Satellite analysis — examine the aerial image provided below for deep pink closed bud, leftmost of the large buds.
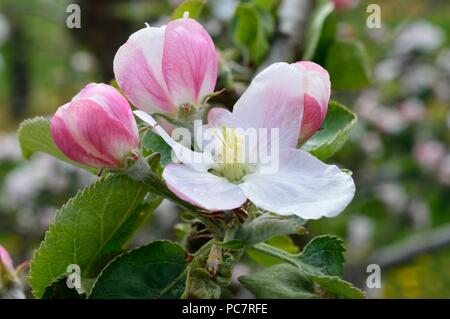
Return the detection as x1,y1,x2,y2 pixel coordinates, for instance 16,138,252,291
51,83,139,168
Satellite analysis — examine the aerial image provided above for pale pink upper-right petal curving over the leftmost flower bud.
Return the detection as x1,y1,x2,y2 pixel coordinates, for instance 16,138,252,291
73,83,139,138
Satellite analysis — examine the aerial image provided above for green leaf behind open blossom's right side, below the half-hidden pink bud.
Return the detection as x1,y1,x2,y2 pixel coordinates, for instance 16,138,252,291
301,101,357,160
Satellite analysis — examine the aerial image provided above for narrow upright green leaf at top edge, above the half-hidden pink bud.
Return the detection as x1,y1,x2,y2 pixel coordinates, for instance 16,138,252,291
303,0,334,60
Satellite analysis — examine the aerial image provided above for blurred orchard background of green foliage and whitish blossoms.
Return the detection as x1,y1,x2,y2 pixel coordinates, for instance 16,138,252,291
0,0,450,298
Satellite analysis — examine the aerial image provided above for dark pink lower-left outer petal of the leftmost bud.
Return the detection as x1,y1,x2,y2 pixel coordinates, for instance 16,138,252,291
50,109,116,168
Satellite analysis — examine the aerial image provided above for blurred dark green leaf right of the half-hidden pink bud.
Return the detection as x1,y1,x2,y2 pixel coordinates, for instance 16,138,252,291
325,40,371,91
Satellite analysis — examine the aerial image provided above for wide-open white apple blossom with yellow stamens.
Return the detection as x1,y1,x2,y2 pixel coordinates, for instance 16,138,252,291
135,63,355,219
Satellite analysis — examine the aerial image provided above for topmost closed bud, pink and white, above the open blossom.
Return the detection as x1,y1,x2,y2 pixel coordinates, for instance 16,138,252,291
114,16,218,115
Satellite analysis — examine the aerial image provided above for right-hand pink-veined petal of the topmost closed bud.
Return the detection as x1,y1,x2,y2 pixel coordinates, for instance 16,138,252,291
163,18,218,106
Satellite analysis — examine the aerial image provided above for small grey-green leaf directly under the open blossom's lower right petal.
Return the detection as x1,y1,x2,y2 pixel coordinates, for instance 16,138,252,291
236,213,306,246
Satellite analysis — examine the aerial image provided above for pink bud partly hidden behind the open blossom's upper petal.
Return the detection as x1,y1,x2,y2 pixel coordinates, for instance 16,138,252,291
294,61,331,143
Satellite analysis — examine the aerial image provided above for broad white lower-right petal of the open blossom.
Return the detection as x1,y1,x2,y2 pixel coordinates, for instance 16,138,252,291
240,149,355,219
